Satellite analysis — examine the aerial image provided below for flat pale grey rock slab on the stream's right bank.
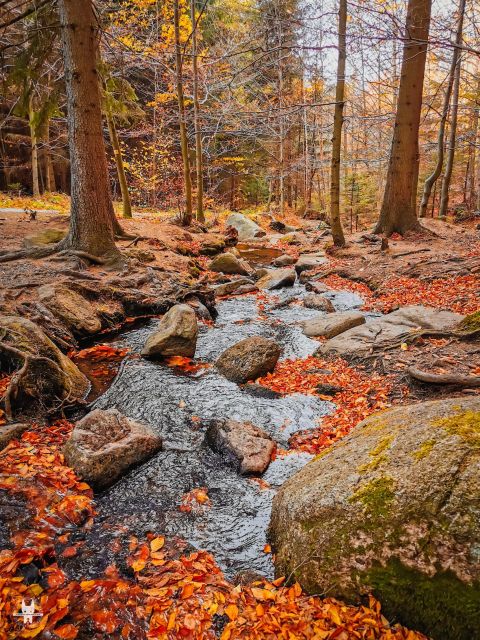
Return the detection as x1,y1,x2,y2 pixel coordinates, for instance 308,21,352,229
319,306,463,356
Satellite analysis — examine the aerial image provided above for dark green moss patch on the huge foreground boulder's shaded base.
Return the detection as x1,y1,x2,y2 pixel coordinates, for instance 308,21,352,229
359,559,480,640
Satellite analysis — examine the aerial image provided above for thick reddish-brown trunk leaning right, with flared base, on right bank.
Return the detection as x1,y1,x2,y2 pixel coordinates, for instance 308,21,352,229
375,0,431,236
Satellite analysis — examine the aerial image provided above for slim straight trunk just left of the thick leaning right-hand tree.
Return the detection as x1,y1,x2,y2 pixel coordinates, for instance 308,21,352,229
330,0,347,247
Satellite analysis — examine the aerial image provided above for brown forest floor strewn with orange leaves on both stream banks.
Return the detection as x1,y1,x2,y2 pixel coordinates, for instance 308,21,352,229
0,202,480,640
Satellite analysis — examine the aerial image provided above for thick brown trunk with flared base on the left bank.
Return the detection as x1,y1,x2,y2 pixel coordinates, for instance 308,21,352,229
58,0,120,261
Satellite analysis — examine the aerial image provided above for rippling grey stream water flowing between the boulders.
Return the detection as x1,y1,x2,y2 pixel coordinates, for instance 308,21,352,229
70,264,362,577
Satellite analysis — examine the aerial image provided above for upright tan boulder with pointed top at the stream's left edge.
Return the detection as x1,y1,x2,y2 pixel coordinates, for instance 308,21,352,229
142,304,198,358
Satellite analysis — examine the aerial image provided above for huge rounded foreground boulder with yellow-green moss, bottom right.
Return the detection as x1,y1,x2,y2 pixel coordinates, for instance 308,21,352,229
270,397,480,640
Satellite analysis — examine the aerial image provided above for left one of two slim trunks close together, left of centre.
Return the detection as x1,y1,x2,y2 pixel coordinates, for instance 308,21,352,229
173,0,192,227
